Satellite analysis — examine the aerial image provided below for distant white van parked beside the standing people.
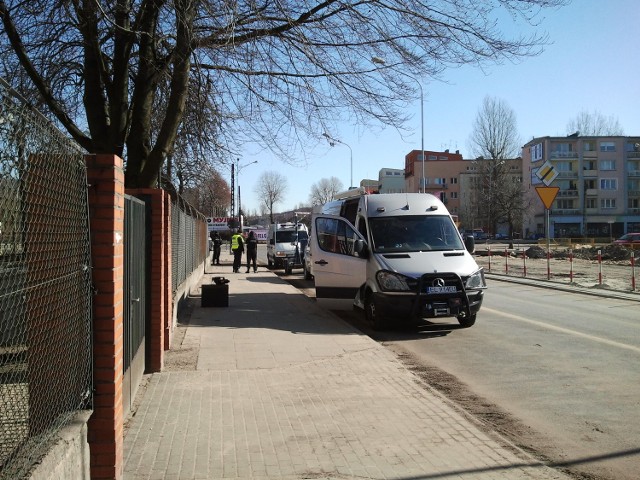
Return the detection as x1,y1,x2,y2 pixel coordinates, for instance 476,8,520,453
267,222,309,273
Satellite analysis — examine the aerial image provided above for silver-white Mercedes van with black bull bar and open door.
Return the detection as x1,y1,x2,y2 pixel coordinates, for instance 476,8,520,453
311,189,486,329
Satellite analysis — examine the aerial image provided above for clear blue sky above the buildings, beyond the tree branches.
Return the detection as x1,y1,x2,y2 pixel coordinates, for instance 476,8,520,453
239,0,640,211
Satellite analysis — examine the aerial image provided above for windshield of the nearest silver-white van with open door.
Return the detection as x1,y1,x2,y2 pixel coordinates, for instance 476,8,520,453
369,215,464,253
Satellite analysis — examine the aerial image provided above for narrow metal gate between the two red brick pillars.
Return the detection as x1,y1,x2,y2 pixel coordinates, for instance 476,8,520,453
122,195,148,409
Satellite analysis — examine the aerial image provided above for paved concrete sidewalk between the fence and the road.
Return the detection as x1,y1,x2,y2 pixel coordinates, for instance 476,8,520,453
124,251,568,480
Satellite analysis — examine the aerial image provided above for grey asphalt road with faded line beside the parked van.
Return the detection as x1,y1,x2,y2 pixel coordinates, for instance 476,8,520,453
258,244,640,480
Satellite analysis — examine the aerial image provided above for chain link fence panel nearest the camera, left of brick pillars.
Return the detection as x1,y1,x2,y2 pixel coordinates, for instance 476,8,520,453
0,79,92,479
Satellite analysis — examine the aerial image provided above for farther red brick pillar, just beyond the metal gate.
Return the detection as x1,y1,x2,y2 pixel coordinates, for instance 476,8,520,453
126,188,171,373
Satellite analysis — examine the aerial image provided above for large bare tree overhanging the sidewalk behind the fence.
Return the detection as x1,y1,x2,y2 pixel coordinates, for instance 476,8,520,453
0,0,568,187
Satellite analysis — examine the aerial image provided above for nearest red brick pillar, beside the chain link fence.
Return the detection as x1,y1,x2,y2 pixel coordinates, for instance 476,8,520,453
86,154,124,480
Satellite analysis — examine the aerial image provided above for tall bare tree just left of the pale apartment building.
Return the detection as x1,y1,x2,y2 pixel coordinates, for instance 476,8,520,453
470,97,524,234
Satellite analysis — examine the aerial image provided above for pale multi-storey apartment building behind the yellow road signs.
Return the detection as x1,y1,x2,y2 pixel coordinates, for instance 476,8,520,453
522,134,640,238
